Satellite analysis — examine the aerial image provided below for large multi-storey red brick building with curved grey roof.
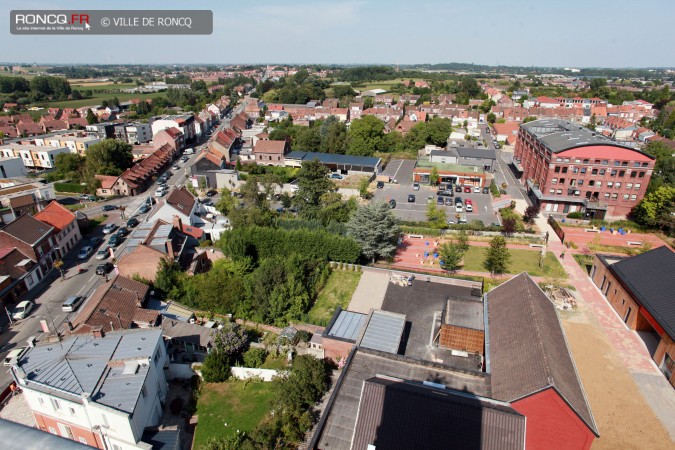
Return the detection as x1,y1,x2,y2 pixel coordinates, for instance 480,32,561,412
514,119,655,219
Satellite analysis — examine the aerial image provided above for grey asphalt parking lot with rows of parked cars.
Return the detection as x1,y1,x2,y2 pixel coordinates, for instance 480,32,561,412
374,182,499,225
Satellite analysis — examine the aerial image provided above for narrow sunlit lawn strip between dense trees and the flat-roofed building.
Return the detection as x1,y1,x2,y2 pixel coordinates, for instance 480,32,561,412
308,269,361,326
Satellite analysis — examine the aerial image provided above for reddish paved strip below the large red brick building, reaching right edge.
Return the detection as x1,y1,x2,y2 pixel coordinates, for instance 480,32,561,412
562,226,668,248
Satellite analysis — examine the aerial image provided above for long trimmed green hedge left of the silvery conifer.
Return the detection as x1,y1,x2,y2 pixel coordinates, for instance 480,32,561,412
218,227,361,263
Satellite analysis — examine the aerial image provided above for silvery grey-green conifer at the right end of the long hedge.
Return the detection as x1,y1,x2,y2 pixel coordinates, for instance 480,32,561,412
347,202,399,263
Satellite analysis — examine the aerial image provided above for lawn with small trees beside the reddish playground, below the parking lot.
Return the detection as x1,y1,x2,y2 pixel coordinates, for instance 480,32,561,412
462,247,567,278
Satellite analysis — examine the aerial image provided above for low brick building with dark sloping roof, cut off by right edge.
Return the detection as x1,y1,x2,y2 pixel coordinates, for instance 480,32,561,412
591,246,675,387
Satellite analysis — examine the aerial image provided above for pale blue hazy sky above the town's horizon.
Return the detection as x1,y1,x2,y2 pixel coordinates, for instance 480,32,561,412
0,0,675,67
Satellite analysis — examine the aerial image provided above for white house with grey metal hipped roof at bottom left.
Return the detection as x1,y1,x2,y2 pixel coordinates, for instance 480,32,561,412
12,324,168,450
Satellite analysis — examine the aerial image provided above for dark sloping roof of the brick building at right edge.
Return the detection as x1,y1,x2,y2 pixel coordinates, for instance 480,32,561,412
609,245,675,339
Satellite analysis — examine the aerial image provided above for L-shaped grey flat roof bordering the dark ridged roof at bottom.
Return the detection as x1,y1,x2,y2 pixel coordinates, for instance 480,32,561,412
312,348,490,450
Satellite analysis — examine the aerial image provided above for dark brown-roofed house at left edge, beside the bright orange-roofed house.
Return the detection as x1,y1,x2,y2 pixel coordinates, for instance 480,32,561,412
0,214,56,280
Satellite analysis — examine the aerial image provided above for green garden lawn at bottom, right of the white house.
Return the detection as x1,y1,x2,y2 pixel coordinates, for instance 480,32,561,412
193,380,272,450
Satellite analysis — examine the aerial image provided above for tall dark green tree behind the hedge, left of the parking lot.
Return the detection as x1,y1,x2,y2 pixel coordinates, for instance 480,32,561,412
293,159,335,219
